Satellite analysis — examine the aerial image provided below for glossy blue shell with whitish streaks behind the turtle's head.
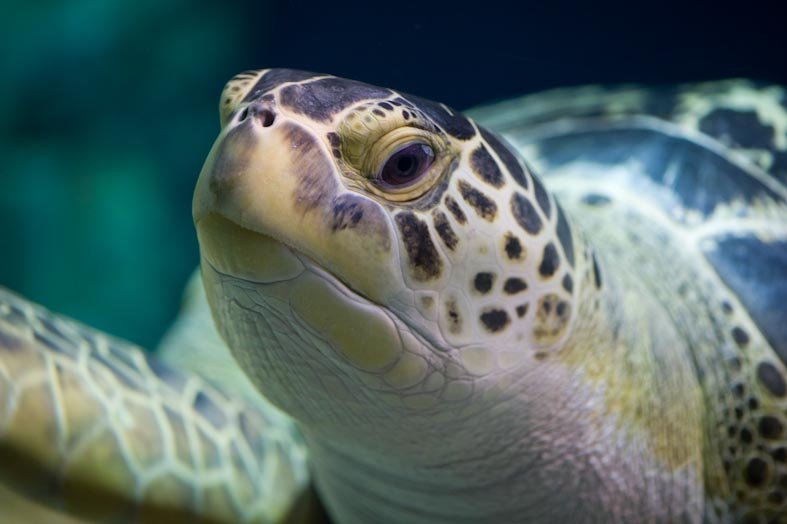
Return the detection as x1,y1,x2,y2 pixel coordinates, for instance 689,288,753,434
471,80,787,365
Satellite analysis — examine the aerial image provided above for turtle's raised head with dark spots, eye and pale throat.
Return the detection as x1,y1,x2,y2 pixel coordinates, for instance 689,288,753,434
193,69,587,446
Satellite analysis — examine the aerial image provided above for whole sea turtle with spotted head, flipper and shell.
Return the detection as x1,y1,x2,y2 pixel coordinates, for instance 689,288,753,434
0,69,787,524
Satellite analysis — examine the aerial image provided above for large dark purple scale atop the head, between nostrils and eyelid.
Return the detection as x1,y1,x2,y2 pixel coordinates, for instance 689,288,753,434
280,77,391,122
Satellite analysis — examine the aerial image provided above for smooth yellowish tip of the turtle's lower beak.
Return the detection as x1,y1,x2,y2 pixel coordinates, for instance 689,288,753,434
196,213,306,284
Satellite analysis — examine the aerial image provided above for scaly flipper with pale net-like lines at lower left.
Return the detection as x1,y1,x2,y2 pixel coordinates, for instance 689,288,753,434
0,289,309,523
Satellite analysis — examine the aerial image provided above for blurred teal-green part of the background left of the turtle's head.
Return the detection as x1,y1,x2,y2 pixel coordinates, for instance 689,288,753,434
0,0,265,347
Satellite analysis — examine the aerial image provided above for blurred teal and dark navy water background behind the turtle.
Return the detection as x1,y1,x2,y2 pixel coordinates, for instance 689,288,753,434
0,0,787,348
